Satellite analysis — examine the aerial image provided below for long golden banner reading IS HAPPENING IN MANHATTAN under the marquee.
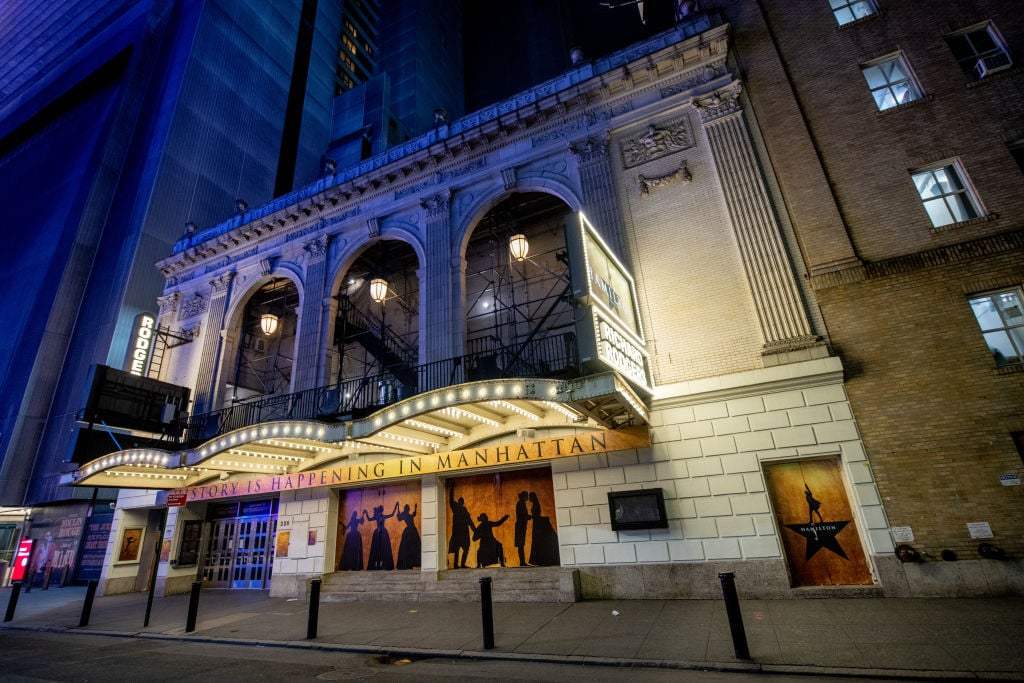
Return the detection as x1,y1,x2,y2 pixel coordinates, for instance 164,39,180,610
179,427,650,503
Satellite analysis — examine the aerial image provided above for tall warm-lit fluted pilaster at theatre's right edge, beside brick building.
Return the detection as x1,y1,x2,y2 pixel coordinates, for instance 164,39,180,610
692,81,818,355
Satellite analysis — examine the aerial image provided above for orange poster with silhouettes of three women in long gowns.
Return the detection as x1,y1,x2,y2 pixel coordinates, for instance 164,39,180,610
335,482,422,571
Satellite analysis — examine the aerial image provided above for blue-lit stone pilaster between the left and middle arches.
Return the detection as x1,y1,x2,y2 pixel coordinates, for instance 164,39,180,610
292,236,330,391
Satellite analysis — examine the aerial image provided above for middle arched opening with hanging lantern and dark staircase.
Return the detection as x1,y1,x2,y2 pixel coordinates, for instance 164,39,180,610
331,240,420,405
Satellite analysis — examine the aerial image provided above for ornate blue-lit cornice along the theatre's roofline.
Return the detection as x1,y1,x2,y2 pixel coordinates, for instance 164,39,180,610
158,10,729,274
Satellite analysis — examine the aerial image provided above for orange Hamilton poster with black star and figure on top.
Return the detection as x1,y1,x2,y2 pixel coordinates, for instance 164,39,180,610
765,458,871,586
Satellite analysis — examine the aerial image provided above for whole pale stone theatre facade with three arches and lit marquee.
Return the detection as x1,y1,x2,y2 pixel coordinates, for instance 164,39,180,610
68,12,899,600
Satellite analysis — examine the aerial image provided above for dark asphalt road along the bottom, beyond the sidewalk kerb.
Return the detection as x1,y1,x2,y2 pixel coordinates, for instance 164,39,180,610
0,631,880,683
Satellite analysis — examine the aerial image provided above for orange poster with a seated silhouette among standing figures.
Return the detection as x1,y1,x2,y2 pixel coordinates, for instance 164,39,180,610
444,467,560,569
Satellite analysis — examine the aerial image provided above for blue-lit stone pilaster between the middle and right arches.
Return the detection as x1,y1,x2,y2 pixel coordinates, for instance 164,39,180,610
420,190,463,364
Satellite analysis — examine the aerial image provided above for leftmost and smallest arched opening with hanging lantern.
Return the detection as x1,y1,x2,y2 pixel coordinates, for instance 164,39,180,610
225,278,299,404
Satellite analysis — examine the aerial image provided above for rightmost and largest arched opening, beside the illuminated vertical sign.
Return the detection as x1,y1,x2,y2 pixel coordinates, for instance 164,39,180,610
465,193,577,379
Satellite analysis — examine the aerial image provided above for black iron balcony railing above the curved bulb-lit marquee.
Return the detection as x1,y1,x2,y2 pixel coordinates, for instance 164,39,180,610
181,332,581,447
